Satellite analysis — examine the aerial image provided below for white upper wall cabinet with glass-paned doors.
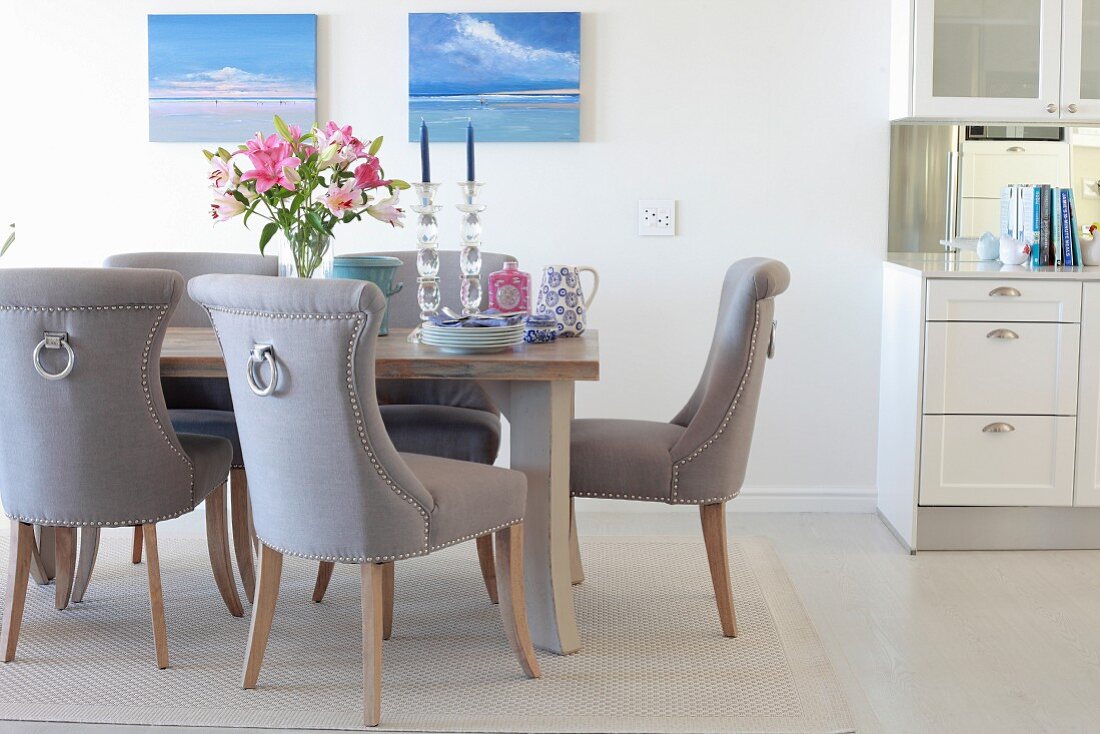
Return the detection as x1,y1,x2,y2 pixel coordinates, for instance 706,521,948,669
890,0,1100,123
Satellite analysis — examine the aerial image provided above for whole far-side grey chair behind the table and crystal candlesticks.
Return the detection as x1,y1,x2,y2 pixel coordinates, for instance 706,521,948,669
314,250,516,604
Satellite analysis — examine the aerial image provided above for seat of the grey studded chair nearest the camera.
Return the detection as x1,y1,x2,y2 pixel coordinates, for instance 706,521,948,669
402,453,527,548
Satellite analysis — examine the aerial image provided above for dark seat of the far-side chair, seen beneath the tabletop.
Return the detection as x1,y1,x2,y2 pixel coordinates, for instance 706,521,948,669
380,405,501,464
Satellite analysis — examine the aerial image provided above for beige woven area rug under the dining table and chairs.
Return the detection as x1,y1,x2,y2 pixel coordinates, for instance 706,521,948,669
0,538,851,734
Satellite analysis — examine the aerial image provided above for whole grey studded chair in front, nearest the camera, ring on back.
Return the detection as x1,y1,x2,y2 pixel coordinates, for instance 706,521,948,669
188,275,539,725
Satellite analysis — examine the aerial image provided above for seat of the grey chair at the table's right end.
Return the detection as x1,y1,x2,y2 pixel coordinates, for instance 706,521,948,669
569,419,684,502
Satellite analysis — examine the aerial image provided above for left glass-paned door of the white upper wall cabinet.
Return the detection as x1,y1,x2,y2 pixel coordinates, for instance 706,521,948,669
913,0,1062,120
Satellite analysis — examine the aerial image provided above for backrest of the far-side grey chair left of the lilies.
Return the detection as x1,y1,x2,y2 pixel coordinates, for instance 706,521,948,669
103,252,278,327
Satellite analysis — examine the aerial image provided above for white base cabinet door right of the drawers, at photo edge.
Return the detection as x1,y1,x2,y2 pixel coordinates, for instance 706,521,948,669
1074,283,1100,507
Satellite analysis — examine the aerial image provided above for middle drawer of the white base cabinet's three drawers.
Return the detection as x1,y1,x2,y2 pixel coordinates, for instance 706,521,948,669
924,321,1081,415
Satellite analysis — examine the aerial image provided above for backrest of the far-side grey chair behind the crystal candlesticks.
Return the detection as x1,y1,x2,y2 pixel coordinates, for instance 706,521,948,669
363,250,516,415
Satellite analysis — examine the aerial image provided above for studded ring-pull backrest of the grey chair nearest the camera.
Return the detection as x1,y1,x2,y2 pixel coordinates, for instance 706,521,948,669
188,275,435,562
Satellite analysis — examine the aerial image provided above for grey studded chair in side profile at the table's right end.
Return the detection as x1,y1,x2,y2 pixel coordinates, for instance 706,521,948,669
570,258,790,637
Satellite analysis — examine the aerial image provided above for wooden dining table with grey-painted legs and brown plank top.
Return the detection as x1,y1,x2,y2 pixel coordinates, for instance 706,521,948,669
161,327,600,655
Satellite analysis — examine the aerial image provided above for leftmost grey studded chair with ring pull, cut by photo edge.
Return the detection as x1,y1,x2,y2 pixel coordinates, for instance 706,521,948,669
0,269,241,668
